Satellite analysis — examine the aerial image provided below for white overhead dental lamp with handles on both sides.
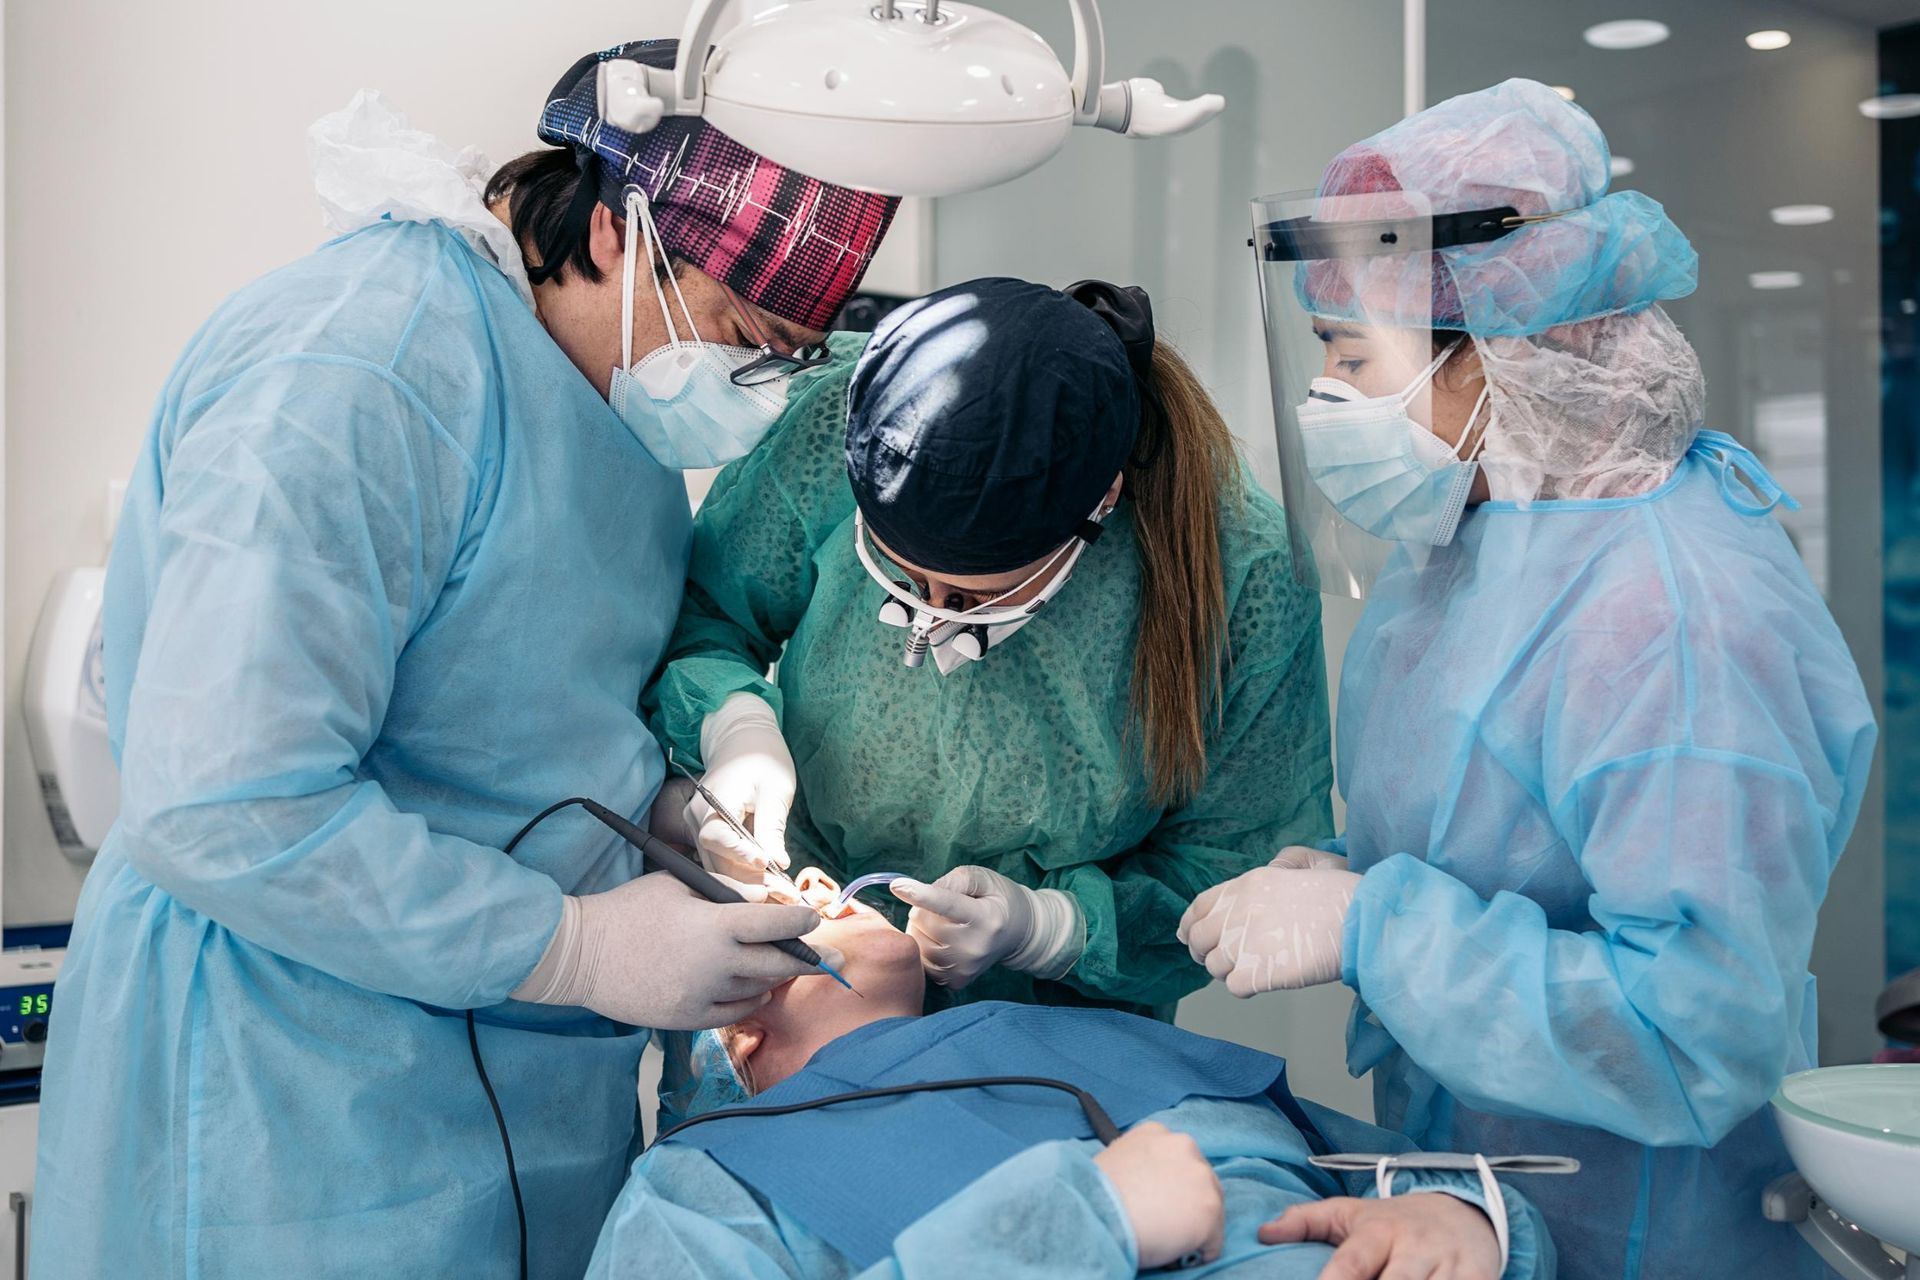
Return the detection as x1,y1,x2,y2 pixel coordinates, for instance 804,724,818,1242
597,0,1225,196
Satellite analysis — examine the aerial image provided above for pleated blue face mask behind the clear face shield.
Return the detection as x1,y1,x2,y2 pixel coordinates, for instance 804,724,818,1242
1296,344,1486,547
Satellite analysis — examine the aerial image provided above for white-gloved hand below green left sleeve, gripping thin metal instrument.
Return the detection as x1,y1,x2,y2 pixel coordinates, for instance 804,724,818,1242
687,693,797,885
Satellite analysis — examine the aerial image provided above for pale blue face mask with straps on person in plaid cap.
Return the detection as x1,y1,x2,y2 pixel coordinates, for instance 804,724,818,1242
607,190,787,470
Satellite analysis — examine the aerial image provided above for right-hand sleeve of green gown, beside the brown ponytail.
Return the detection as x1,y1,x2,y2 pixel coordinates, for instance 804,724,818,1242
1043,558,1332,1006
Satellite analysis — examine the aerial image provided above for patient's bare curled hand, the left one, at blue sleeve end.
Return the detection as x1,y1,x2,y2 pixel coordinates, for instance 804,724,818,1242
1092,1123,1227,1270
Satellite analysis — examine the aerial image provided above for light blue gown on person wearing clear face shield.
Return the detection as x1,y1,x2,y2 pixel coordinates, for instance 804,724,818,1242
1338,438,1874,1280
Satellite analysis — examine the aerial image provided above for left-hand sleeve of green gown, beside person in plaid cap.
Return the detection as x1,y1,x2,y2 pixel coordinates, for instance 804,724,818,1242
641,360,854,760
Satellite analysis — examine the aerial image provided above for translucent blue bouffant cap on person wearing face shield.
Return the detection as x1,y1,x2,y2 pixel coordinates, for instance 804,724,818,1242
1296,79,1699,338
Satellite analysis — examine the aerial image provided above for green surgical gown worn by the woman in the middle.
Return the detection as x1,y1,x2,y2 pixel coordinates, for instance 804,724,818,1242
647,345,1331,1017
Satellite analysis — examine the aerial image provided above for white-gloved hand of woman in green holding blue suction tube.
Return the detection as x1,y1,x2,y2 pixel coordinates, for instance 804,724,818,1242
889,865,1087,990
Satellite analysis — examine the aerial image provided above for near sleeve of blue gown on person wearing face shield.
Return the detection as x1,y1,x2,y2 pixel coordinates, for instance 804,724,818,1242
1344,747,1834,1146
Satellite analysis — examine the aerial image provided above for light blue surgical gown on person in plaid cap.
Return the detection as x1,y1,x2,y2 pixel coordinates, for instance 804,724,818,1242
33,223,689,1280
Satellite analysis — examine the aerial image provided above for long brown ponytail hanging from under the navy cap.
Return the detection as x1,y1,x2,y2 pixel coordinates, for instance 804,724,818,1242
1123,342,1244,808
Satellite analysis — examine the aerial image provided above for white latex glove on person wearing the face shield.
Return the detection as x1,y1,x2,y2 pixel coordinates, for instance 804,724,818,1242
1175,865,1359,998
